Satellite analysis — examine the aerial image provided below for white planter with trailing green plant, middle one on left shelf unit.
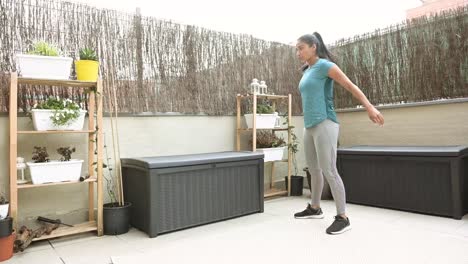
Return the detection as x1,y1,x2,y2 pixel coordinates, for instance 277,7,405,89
31,109,86,131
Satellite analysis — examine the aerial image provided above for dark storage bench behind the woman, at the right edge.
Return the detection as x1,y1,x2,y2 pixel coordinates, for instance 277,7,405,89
337,146,468,219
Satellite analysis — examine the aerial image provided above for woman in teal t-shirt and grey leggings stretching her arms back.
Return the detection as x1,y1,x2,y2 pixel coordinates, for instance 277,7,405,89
294,32,384,234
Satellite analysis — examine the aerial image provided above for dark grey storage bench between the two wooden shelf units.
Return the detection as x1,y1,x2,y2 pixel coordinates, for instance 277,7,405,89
122,152,264,237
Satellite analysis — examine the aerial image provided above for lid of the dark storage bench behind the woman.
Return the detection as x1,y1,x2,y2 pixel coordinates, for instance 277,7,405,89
338,146,468,157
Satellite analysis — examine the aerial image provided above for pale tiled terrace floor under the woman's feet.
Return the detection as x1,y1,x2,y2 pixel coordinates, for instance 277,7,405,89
4,192,468,264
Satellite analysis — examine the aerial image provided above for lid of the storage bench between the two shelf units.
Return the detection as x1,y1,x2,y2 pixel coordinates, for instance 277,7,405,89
121,151,264,169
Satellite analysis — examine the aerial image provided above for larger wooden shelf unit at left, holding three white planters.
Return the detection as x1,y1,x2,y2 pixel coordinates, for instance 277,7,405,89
9,72,103,241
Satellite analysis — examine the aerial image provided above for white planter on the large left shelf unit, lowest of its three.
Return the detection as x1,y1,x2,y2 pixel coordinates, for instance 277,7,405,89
26,159,83,184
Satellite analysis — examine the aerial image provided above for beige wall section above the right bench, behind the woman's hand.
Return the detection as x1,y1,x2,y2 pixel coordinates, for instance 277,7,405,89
338,100,468,146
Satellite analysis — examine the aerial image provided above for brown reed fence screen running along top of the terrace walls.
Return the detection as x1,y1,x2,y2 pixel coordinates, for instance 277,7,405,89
0,0,468,115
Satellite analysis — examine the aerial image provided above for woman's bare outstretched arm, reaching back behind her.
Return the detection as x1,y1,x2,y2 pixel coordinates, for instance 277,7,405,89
328,65,384,126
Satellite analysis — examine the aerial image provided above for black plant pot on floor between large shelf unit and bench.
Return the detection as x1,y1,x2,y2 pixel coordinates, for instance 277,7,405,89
103,202,132,235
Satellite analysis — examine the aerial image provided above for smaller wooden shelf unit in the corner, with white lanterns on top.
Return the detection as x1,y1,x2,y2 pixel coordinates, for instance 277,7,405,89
236,93,292,198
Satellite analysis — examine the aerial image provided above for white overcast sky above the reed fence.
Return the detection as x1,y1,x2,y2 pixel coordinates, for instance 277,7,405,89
68,0,422,44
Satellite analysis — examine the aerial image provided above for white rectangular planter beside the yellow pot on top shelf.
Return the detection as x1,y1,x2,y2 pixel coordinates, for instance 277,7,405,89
16,54,73,80
